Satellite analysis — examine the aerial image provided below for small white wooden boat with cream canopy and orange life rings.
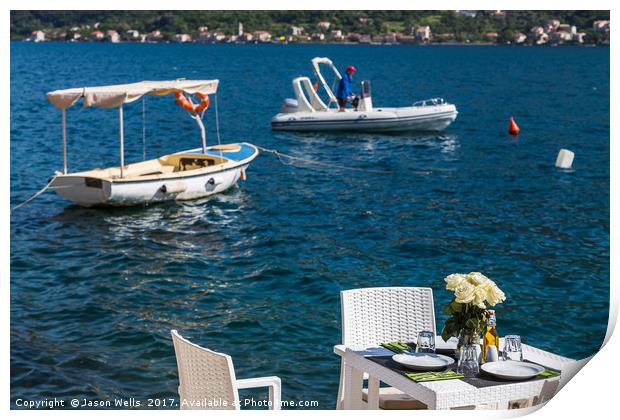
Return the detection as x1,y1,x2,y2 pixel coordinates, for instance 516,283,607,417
47,80,258,207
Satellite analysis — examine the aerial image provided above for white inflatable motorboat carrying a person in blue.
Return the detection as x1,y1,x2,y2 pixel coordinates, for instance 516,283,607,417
271,57,458,132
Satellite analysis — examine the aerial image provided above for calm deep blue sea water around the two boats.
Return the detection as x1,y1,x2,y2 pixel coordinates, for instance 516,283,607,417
10,43,610,408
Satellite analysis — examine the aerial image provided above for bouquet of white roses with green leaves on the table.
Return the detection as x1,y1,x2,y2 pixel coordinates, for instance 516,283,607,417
441,272,506,340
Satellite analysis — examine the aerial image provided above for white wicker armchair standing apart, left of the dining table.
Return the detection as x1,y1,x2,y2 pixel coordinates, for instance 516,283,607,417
171,330,281,410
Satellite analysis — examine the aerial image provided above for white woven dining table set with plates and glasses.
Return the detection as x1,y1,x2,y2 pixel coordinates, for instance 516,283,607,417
334,337,575,410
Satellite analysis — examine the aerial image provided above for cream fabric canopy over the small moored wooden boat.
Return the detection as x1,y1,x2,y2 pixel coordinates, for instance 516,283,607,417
46,79,219,111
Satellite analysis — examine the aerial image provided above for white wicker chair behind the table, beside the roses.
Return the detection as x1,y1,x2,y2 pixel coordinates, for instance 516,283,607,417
334,287,436,409
